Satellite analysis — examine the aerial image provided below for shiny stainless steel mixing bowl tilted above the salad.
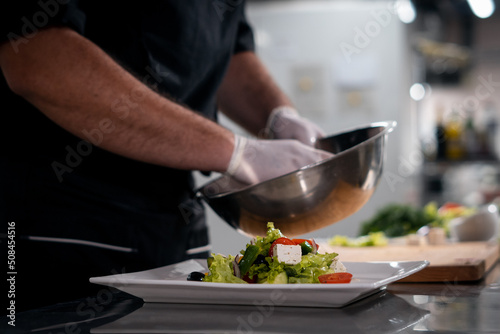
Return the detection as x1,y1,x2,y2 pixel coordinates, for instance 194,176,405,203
197,121,396,237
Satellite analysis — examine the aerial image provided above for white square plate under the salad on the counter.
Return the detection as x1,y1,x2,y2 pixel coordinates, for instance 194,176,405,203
90,260,429,307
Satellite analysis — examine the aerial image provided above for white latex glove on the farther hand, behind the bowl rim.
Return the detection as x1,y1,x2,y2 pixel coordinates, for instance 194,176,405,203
267,106,325,146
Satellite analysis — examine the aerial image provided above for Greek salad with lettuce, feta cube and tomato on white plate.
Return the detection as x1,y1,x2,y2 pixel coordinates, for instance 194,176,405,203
188,223,352,284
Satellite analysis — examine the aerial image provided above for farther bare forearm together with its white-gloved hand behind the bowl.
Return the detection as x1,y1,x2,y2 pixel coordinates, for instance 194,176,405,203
217,52,324,146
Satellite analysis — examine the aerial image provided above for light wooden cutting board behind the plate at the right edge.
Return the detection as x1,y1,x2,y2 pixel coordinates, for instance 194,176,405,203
319,242,499,282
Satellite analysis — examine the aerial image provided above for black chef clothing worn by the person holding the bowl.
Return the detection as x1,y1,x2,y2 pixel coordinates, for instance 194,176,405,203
0,0,253,310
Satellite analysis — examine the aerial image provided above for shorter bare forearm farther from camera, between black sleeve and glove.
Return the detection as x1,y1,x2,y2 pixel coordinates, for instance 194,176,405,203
217,52,292,135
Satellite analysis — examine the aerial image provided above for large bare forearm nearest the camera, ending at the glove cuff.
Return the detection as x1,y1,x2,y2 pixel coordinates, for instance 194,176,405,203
0,28,234,171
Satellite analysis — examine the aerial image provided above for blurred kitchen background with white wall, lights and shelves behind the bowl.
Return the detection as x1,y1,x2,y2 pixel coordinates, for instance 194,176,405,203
197,0,500,254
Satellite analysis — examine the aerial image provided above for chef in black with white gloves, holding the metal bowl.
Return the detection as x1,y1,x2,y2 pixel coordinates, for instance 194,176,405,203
0,0,328,310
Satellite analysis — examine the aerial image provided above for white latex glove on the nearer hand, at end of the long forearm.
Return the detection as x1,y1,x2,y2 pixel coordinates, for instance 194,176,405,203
227,135,333,184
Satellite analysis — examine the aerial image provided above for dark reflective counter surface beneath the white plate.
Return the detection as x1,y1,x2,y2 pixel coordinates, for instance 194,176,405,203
0,263,500,334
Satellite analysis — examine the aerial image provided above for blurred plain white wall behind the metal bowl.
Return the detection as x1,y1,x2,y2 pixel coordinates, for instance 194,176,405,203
198,0,419,253
